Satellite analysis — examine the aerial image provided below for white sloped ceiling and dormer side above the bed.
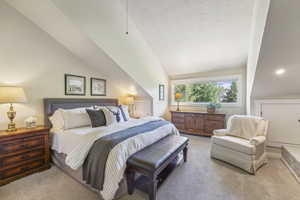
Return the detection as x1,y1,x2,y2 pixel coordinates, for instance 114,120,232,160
6,0,168,116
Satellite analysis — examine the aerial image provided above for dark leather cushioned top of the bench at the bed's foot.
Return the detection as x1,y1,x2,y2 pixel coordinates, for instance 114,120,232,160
127,135,188,171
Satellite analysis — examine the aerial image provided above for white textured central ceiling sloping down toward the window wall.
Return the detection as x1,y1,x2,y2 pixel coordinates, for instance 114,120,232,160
120,0,254,75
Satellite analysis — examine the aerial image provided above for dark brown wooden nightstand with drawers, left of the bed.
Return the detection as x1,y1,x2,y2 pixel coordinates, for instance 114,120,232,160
0,126,50,186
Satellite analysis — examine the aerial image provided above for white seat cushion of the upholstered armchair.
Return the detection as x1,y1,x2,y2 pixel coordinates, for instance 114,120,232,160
211,136,256,155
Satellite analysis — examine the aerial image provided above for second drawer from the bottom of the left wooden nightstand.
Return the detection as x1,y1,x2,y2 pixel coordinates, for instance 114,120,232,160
0,149,45,168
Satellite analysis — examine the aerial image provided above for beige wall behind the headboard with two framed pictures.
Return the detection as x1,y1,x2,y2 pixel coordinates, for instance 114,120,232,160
0,2,151,129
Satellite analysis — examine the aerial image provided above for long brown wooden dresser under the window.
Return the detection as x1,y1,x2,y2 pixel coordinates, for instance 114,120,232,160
171,111,226,136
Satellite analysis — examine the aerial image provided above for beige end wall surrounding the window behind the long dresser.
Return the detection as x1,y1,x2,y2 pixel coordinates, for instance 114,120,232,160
166,67,246,119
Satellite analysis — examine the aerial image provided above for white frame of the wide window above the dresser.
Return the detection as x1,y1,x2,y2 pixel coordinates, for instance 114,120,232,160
171,75,243,107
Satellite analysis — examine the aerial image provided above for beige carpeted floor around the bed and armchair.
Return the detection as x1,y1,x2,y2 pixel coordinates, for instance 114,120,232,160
0,136,300,200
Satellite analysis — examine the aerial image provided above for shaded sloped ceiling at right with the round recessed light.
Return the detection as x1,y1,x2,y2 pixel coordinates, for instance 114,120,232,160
252,0,300,98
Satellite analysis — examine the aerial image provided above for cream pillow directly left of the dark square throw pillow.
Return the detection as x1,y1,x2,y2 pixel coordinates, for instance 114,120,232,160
61,108,91,130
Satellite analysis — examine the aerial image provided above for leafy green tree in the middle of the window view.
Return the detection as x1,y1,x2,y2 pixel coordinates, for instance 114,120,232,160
188,82,220,102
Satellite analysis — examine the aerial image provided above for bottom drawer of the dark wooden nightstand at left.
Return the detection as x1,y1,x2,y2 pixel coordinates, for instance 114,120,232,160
0,160,45,179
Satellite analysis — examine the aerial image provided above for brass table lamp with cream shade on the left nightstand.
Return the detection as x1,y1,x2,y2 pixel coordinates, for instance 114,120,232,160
0,86,27,132
